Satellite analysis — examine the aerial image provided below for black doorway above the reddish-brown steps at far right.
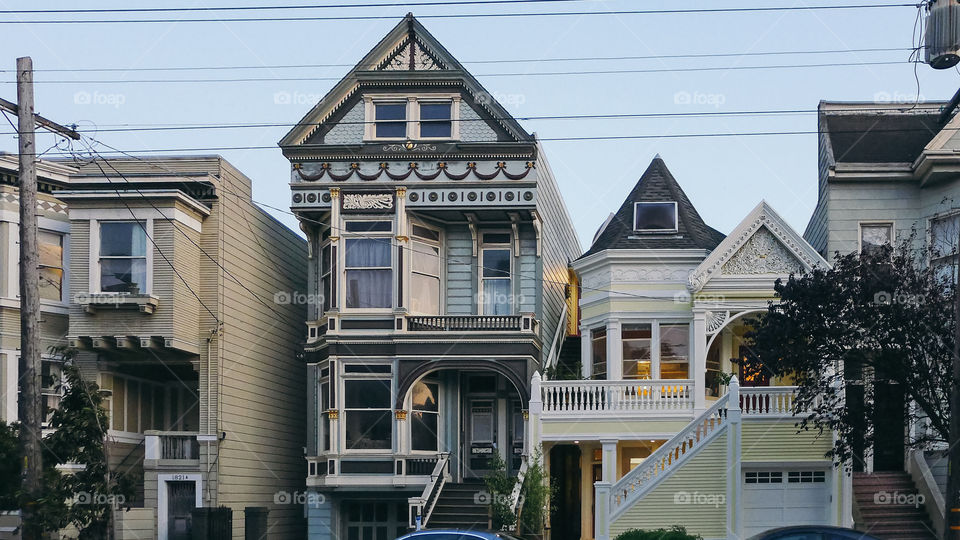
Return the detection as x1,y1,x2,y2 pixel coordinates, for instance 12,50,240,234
873,382,906,472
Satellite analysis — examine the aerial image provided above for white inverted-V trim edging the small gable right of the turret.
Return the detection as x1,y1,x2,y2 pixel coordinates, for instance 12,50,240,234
687,201,829,293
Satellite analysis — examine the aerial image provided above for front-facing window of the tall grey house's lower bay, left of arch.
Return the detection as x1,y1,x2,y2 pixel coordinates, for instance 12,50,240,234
343,378,393,450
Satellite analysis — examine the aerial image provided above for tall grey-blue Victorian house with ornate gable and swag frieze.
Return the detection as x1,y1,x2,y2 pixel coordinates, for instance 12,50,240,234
280,15,580,539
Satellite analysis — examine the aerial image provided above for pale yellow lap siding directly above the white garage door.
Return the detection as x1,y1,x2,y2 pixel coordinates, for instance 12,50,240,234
741,418,833,461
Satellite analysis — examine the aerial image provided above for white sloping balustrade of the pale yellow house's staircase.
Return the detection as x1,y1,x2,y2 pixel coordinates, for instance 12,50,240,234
597,392,738,520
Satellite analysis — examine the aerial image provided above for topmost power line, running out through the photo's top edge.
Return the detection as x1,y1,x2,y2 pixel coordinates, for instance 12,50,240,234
0,0,585,15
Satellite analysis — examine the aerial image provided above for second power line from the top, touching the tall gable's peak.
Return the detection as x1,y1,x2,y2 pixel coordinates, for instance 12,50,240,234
0,3,923,25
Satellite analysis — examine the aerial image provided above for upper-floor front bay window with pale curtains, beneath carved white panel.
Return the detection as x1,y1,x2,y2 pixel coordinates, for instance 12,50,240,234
343,221,393,309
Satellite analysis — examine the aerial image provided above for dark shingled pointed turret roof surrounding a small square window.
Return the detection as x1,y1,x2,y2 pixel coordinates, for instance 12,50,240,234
581,155,724,258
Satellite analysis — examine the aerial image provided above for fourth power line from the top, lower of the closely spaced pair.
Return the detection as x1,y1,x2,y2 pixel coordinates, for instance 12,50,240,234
2,60,917,84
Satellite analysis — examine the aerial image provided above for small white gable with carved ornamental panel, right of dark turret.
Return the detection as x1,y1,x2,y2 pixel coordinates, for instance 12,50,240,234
687,201,830,292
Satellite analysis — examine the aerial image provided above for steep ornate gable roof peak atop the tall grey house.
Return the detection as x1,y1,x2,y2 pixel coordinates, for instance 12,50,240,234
279,13,533,147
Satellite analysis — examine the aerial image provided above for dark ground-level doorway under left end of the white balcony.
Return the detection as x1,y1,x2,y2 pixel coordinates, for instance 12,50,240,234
550,444,580,540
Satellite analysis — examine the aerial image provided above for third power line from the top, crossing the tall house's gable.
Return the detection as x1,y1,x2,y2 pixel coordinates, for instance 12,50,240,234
0,47,916,73
